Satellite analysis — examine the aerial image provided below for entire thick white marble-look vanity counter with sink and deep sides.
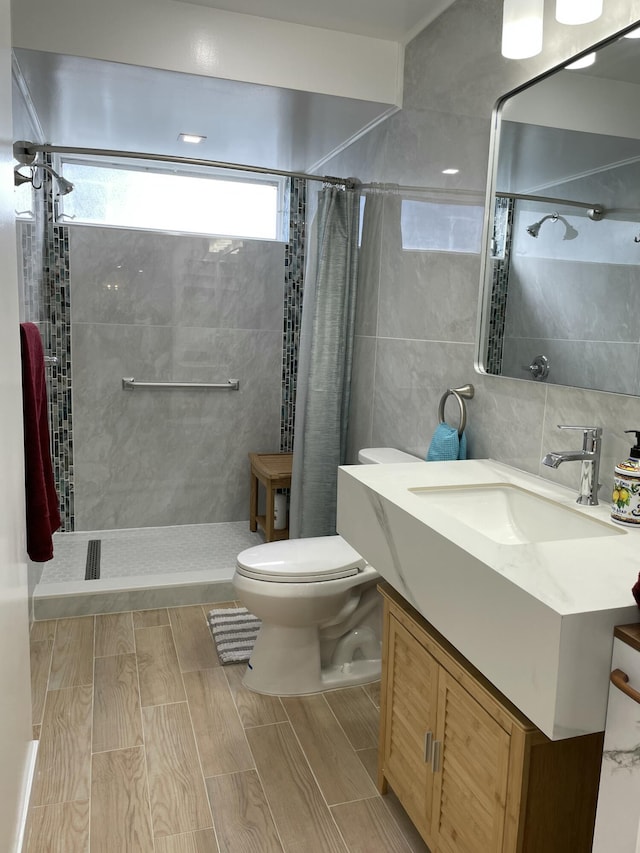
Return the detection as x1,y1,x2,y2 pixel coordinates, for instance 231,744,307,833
338,459,640,739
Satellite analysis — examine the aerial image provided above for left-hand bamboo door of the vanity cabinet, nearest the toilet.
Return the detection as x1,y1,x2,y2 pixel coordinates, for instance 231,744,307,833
383,616,439,839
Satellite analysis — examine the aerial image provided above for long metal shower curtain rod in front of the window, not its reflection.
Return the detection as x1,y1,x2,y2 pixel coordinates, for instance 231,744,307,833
13,141,359,189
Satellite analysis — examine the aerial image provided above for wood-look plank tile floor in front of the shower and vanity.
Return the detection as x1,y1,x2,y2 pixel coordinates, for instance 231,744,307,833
24,604,428,853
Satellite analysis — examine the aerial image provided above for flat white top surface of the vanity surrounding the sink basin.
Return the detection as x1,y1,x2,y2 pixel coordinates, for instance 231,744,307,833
338,459,640,619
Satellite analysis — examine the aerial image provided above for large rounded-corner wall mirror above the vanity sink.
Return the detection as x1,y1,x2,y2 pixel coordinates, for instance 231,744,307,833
477,25,640,395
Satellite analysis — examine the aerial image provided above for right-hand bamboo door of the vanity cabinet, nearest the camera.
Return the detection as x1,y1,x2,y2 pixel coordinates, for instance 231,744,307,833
432,670,510,853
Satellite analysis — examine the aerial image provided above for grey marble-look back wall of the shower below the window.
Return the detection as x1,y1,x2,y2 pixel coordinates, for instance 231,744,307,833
69,227,284,530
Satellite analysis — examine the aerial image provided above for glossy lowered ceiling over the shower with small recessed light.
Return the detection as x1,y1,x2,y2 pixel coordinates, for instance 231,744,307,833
14,49,391,171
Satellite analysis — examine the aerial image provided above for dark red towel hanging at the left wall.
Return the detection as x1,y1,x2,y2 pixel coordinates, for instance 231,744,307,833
20,323,61,563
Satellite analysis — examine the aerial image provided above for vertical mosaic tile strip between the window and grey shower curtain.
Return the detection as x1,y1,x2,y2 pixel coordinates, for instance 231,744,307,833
280,178,307,453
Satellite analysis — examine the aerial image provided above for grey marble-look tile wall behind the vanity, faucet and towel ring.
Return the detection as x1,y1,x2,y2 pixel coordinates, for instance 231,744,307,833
326,0,640,500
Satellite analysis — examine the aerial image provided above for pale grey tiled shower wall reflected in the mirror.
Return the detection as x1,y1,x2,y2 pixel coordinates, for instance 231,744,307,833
502,156,640,394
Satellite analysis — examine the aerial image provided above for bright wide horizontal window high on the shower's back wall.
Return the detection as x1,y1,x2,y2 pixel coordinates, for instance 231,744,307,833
58,160,288,240
